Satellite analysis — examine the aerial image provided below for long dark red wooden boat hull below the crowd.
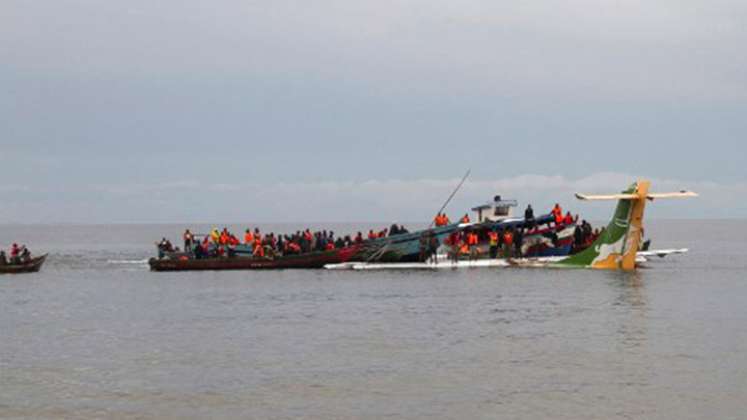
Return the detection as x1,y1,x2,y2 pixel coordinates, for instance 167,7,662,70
148,245,359,271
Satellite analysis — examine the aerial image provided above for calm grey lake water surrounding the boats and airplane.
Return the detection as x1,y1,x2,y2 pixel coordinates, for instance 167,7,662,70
0,220,747,420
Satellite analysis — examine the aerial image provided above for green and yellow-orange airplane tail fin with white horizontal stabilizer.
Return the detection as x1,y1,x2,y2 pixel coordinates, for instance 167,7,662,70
558,180,698,271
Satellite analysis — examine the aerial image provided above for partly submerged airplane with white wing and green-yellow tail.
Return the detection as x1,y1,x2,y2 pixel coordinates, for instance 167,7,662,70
326,180,698,271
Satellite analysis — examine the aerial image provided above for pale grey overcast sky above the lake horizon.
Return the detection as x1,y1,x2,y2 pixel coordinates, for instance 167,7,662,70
0,0,747,223
